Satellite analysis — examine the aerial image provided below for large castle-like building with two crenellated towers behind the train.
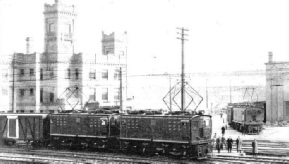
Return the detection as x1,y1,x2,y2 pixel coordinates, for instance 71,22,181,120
10,0,127,113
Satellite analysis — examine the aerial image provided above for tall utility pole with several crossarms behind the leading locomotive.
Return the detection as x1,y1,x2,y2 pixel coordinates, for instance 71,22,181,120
177,27,189,111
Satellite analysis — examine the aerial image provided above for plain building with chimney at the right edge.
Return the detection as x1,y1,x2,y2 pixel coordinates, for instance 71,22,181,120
265,52,289,124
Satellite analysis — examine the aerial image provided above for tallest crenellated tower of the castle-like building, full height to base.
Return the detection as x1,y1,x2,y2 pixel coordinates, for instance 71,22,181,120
39,0,82,112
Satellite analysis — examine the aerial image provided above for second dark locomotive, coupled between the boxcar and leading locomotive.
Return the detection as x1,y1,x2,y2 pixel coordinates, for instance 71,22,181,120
50,113,119,149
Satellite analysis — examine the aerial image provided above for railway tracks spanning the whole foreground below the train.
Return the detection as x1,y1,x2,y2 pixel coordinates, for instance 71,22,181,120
0,140,289,163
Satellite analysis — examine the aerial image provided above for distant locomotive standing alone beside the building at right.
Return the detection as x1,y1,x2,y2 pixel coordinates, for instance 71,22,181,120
227,102,265,134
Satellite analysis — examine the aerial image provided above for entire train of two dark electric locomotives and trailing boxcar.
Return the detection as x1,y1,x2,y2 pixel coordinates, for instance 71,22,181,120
0,112,212,158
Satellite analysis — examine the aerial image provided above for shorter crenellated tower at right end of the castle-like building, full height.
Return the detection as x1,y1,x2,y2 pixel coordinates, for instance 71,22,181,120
101,32,127,110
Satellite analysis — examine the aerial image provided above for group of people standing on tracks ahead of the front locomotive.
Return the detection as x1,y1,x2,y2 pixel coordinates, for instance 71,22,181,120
213,127,258,156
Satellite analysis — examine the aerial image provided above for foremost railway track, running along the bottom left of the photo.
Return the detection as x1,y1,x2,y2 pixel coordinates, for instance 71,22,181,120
0,148,192,163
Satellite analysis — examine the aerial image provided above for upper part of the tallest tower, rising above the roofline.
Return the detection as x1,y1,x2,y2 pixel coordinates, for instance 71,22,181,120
43,0,77,58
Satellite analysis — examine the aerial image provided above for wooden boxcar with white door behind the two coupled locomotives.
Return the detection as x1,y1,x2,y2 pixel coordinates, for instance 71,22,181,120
0,113,49,146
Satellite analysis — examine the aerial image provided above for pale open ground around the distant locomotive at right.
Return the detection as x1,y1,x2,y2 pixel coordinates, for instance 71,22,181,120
212,115,289,142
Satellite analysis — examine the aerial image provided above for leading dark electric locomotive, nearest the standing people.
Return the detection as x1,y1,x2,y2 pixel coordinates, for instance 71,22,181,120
120,115,212,158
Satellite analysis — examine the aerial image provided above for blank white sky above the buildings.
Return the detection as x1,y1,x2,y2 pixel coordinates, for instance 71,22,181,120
0,0,289,110
